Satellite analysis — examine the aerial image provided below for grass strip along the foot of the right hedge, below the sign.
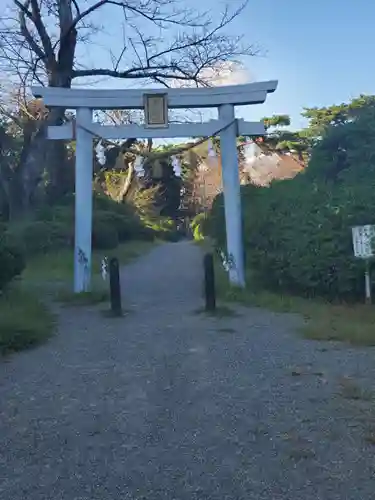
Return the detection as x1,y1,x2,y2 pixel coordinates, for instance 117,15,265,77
215,258,375,346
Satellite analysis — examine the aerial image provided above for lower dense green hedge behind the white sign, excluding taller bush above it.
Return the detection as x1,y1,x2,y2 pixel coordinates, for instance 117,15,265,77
208,174,375,300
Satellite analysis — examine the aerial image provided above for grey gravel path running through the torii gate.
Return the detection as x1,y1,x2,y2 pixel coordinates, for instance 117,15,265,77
0,242,375,500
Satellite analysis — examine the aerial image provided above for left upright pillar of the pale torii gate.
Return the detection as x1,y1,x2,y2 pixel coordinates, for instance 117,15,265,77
74,108,93,293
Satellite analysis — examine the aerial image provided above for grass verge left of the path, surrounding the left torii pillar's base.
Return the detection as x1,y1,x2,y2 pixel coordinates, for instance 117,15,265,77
0,241,155,355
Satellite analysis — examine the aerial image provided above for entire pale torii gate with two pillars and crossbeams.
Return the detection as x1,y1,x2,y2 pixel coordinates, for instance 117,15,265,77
32,81,278,293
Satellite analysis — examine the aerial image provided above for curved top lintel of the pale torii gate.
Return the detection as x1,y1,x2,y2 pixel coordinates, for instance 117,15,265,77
32,80,278,109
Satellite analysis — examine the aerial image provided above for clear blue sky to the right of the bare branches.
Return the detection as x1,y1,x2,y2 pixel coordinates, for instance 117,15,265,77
75,0,375,128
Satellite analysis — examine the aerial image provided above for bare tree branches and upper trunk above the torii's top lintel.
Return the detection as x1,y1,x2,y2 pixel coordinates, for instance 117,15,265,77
0,0,259,87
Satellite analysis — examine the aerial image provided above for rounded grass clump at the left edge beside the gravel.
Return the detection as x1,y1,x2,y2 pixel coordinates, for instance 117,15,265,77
0,284,55,355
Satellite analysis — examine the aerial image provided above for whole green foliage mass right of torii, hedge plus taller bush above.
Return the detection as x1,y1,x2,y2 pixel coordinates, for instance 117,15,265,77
207,97,375,300
